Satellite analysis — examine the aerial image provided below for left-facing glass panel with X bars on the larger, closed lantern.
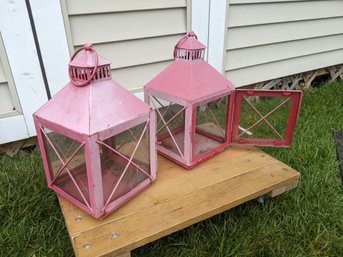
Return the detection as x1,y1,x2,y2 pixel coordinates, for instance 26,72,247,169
43,128,89,204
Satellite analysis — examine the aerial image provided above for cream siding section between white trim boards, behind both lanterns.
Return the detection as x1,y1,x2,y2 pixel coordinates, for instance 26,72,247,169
61,0,189,91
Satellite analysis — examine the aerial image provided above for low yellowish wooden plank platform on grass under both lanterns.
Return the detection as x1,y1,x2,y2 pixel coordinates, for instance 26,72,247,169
59,146,299,257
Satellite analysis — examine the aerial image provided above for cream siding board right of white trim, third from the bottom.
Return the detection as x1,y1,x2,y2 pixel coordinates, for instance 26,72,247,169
227,18,343,49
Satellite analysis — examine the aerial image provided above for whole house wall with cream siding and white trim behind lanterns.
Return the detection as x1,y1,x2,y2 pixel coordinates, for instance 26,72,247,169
0,0,343,144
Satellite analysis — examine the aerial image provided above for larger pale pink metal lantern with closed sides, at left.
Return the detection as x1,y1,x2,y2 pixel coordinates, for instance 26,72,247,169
34,44,156,218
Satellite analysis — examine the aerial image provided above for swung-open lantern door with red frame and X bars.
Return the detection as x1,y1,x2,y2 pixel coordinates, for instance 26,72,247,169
232,89,302,147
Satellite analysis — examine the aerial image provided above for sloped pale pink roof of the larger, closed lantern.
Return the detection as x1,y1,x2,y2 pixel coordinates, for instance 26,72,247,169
35,44,150,135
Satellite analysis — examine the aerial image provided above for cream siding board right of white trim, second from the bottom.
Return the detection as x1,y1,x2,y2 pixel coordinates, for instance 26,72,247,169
225,34,343,70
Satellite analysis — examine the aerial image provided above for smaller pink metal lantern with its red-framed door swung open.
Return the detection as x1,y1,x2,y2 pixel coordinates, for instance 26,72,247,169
144,32,302,168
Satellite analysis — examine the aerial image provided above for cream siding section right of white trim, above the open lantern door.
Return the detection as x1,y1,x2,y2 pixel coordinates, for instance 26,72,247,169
224,0,343,86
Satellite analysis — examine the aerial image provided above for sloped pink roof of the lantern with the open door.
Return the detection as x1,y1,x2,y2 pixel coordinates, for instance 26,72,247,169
144,34,235,102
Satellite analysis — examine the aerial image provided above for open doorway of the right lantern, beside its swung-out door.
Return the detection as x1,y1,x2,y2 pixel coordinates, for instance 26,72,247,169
194,96,229,156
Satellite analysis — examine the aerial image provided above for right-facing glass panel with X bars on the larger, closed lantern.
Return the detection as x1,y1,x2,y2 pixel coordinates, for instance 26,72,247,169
100,122,150,202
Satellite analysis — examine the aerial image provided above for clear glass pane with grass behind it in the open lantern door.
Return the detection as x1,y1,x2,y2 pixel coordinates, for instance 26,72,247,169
238,96,292,139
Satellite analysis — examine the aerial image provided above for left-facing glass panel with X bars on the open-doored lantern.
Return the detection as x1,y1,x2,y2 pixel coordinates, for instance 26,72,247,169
152,97,185,157
